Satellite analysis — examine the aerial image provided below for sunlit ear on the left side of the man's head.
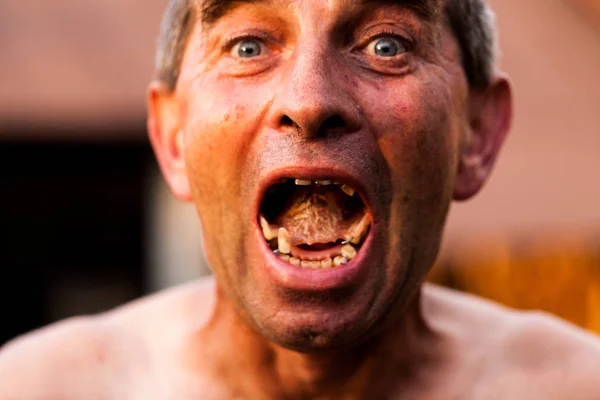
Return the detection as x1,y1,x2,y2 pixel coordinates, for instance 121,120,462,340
148,82,192,201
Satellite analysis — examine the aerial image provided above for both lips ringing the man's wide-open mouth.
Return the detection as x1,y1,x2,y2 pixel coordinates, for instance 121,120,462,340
252,168,376,292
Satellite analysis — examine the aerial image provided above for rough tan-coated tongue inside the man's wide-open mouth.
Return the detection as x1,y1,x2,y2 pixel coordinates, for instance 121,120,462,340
275,187,350,246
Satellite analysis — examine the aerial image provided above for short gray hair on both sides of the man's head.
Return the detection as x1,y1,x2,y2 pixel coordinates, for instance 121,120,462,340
155,0,497,91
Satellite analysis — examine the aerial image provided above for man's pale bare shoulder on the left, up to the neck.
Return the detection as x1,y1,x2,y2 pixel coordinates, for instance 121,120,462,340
0,281,212,400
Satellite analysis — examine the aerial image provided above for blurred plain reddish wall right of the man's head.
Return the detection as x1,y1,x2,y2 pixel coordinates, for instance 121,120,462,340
447,0,600,239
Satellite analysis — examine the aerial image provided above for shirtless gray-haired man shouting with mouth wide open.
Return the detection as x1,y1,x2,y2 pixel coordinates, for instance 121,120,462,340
0,0,600,400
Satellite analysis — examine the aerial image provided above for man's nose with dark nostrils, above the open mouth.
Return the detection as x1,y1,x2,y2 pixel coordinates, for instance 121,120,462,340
269,51,361,139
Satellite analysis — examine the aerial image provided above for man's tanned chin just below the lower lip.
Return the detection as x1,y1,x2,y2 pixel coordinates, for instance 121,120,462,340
243,238,408,353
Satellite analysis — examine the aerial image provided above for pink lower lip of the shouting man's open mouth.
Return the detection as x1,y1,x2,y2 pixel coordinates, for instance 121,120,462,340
255,222,373,292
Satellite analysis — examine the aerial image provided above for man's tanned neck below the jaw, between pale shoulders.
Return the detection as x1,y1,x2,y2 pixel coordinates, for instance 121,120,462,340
195,282,436,398
